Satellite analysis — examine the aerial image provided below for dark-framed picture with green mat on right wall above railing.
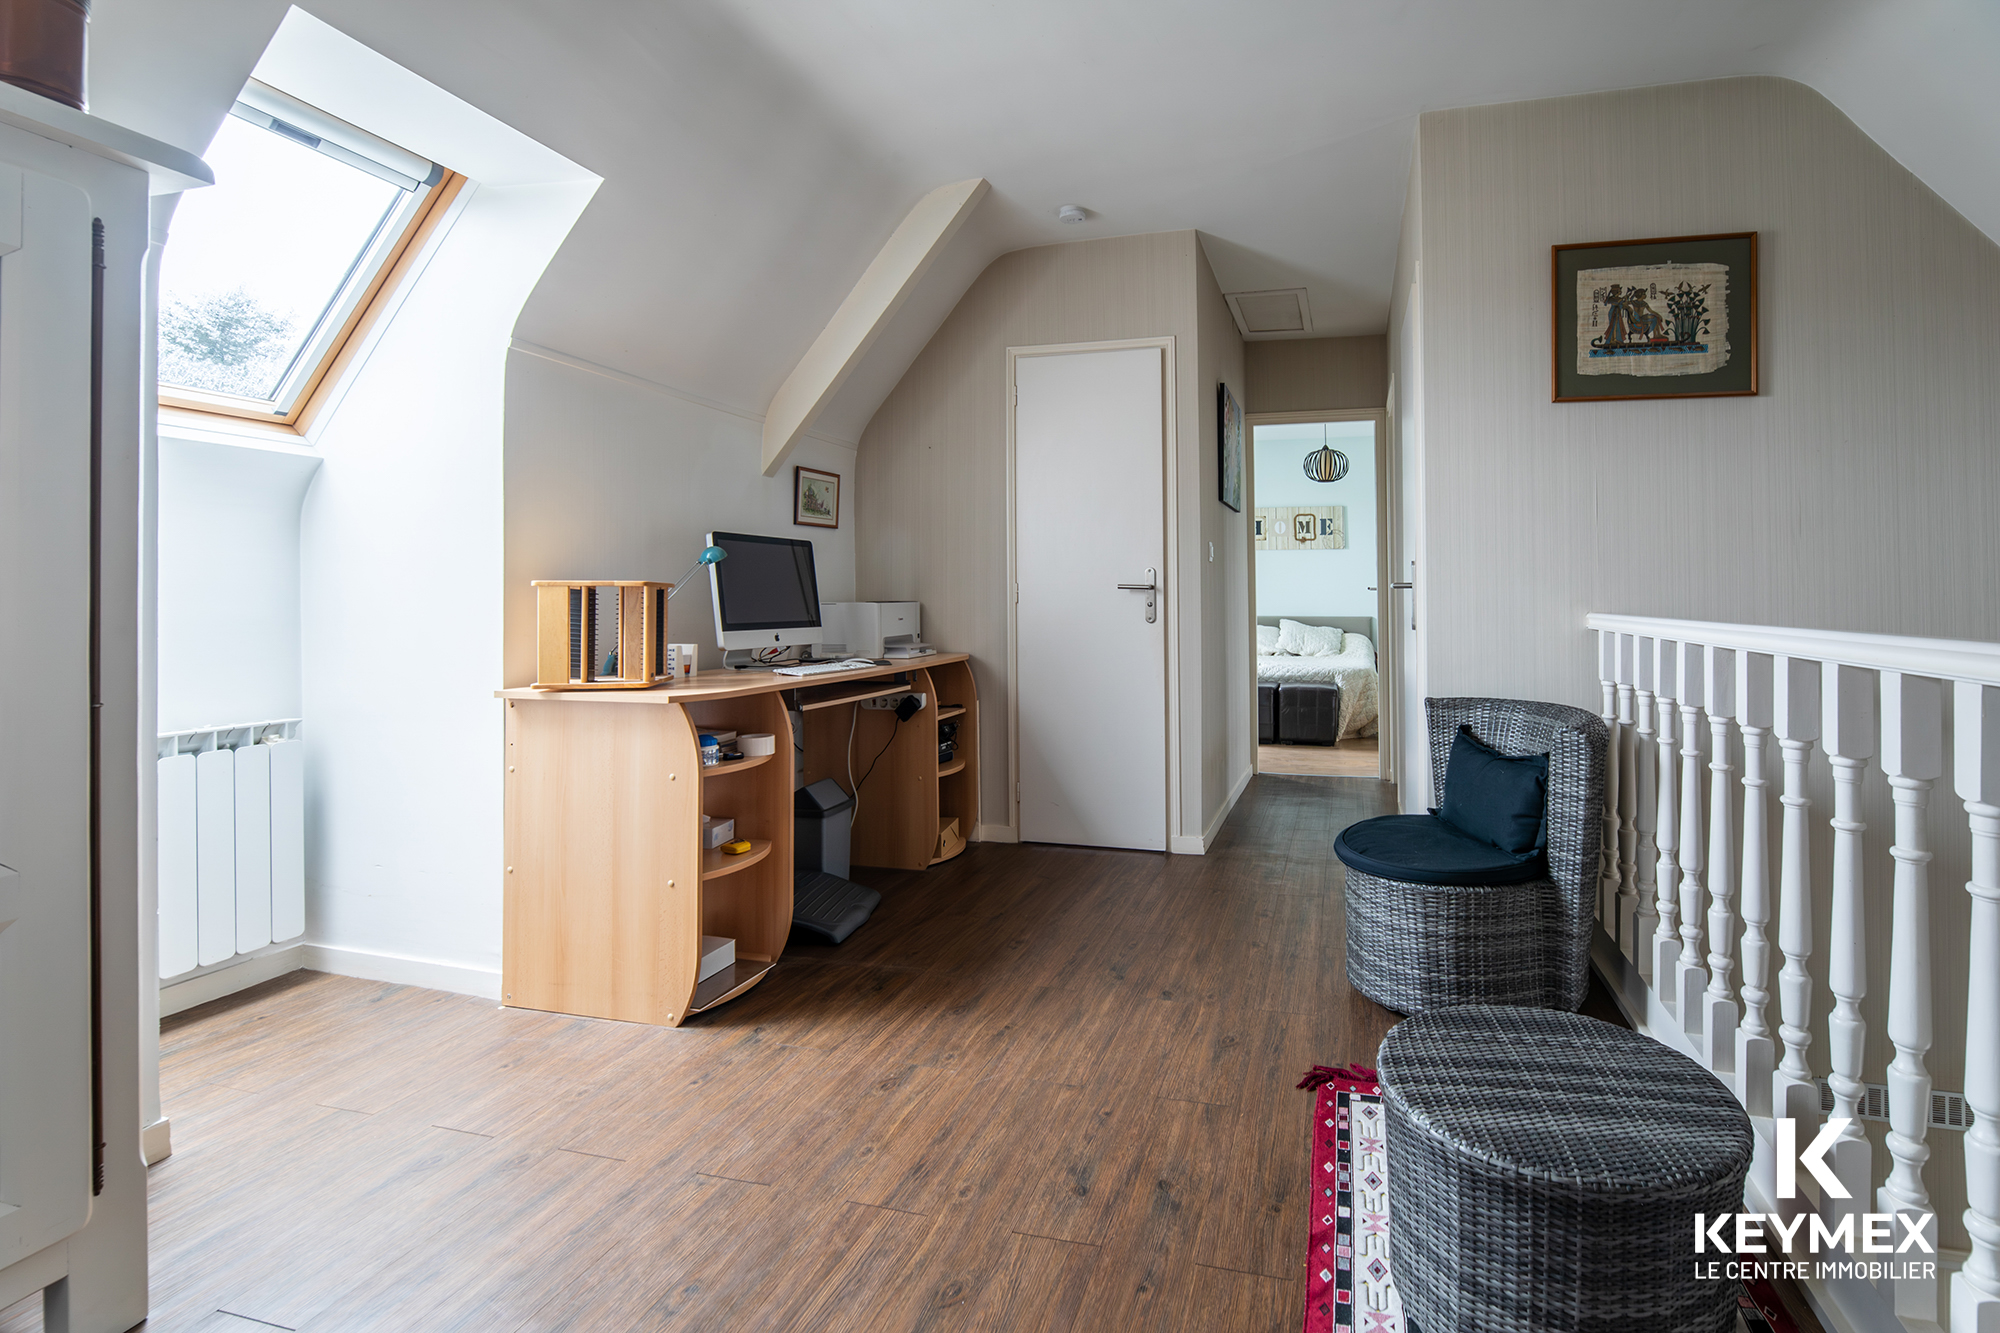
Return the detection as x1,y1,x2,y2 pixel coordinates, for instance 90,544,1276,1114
1550,232,1758,402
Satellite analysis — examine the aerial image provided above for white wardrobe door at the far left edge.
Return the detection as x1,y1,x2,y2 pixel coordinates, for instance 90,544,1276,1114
0,164,92,1264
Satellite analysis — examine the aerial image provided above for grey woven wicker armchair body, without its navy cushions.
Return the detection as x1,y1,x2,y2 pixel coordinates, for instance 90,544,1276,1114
1336,699,1606,1013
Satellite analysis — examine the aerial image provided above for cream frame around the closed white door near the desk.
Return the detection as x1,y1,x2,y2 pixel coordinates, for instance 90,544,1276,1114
1002,334,1182,849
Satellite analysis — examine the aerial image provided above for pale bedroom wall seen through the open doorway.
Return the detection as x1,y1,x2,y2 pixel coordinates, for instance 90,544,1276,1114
1256,420,1376,616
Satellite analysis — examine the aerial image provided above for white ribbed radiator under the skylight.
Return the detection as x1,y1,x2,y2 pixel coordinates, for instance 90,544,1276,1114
160,719,306,979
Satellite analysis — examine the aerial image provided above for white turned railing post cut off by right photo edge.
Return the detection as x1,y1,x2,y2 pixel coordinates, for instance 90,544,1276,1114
1952,681,2000,1333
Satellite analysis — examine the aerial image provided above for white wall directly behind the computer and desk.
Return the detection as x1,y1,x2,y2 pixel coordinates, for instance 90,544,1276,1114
506,346,858,687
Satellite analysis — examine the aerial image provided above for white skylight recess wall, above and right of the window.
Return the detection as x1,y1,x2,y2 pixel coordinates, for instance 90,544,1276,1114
238,10,598,984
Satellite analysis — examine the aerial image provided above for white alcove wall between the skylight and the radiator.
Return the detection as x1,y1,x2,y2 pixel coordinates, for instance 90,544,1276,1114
158,428,320,731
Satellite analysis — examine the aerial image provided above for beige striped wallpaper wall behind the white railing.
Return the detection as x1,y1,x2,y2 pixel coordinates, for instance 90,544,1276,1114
1400,78,2000,1245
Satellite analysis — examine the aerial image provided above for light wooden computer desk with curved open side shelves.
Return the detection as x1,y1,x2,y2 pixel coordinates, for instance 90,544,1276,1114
500,652,980,1027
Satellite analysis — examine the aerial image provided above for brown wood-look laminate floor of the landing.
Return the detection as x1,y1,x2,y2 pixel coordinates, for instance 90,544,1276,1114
0,777,1394,1333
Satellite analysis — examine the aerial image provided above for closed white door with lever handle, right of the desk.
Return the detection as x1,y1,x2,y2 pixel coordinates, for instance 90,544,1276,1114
1014,346,1168,851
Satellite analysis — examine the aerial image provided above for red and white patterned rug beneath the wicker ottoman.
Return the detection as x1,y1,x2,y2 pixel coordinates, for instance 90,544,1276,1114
1298,1065,1800,1333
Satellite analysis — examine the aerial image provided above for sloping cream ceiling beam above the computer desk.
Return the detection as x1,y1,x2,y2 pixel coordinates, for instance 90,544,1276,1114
764,178,992,476
